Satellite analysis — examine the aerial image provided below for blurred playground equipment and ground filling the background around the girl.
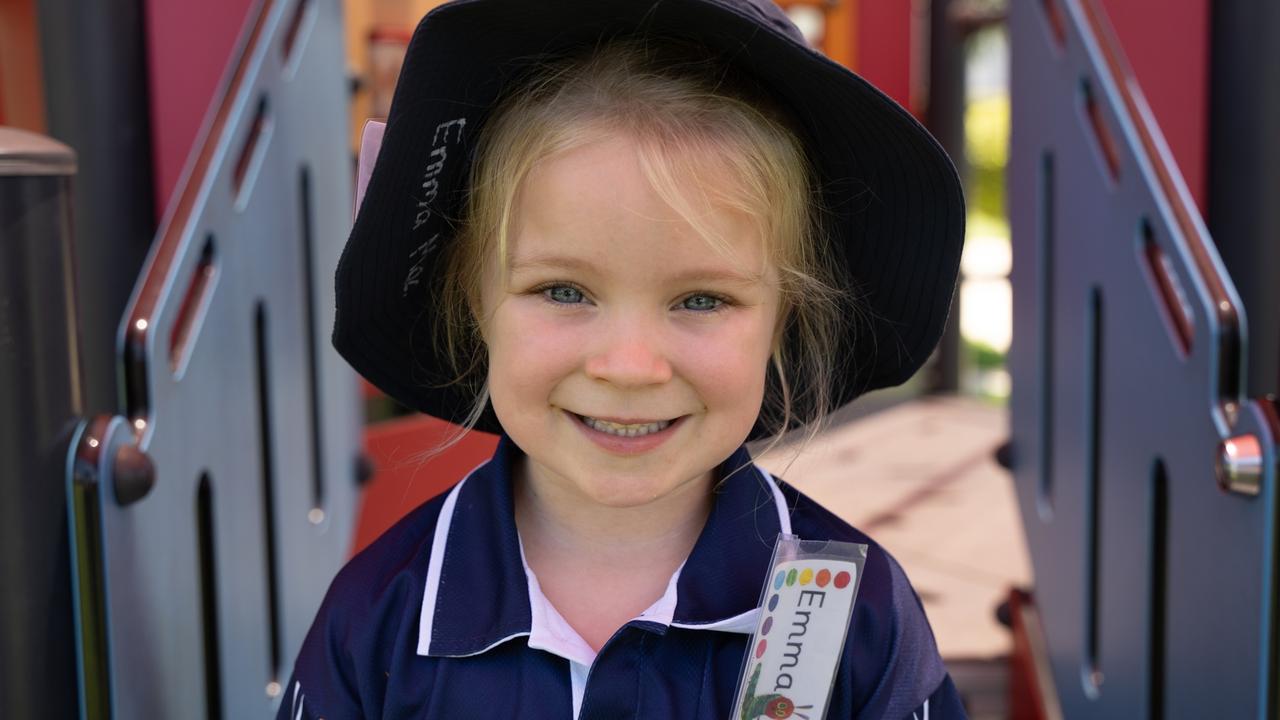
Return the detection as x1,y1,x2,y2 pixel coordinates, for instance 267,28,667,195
0,0,1280,719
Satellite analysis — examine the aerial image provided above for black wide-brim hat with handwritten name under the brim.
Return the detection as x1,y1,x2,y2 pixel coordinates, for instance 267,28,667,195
333,0,965,437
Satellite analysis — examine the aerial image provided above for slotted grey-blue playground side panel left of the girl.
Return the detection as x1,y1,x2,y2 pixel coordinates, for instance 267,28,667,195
72,0,360,719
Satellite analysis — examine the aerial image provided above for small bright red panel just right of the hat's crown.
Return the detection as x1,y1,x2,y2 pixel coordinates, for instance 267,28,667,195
854,0,915,111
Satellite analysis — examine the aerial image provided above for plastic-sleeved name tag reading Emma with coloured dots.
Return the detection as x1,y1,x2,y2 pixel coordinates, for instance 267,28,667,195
731,534,867,720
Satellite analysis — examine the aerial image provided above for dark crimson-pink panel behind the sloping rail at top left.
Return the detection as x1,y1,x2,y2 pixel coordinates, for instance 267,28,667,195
146,0,253,219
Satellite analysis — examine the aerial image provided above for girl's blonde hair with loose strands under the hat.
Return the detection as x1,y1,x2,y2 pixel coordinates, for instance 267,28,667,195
434,38,852,447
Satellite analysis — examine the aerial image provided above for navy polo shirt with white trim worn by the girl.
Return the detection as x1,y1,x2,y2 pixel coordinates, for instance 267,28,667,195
279,438,964,720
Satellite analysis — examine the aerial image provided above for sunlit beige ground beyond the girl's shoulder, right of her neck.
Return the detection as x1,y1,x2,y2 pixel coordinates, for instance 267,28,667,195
759,397,1032,661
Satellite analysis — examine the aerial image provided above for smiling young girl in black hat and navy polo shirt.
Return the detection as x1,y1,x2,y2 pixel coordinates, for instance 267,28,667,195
280,0,964,720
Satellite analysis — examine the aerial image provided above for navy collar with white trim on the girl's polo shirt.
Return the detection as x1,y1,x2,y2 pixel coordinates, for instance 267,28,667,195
417,436,791,657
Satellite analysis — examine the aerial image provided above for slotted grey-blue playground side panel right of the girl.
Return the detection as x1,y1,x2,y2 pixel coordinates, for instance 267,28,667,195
1009,0,1275,719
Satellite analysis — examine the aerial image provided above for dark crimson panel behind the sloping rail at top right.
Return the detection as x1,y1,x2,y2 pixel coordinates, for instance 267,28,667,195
1101,0,1210,211
